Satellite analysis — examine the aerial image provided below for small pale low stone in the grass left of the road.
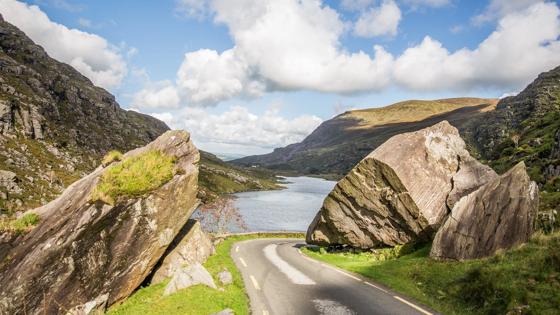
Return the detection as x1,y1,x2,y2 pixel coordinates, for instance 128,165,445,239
163,263,218,296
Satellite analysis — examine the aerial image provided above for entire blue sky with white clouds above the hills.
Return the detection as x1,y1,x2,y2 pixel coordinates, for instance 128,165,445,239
0,0,560,155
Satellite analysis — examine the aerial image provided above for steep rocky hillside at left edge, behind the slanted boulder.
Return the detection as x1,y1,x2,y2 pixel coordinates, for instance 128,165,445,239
0,13,169,212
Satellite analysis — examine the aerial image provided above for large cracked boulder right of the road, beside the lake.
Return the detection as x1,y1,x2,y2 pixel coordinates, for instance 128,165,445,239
307,121,497,248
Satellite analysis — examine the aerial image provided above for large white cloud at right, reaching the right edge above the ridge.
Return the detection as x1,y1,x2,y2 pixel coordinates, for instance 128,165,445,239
394,3,560,90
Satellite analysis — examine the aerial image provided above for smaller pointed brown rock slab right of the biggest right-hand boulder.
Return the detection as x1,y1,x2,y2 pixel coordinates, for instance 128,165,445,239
430,162,539,260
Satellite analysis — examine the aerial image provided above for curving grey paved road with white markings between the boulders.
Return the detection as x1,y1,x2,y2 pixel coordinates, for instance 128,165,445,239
231,239,432,315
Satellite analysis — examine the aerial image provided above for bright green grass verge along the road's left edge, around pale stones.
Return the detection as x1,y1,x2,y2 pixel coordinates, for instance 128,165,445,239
108,233,302,315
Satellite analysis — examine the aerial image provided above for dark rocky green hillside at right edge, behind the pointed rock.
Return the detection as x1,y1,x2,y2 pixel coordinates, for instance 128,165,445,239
463,67,560,216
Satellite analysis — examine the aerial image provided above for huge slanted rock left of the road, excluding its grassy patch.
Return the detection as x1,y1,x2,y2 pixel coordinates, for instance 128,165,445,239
0,131,199,314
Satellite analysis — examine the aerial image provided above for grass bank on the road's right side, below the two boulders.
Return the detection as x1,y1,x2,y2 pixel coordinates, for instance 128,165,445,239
303,233,560,314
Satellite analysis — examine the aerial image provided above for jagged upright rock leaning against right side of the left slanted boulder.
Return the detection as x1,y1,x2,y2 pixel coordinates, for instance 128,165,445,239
151,220,214,283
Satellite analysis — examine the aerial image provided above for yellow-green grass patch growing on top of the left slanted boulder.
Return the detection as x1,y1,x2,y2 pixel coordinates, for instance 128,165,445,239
90,150,175,204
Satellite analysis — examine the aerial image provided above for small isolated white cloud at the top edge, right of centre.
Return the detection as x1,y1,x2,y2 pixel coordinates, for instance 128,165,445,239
354,0,401,37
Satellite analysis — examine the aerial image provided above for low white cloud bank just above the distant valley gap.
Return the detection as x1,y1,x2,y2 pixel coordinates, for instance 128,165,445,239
152,106,322,149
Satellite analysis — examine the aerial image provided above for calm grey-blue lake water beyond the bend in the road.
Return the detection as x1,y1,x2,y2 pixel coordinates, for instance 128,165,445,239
235,177,336,232
